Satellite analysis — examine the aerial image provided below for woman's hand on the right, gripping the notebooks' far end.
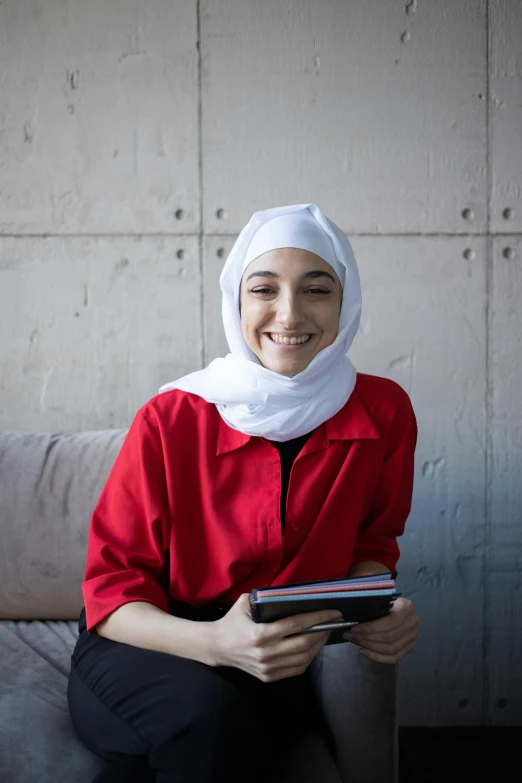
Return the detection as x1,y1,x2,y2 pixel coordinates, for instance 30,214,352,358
343,598,419,663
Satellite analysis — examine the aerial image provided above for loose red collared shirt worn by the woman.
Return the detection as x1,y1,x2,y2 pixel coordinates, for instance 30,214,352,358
83,374,417,633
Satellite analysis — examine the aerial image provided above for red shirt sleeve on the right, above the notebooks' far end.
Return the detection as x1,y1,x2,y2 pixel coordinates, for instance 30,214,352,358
352,393,417,571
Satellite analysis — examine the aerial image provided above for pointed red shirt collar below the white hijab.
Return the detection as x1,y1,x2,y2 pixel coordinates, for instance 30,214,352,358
216,389,380,454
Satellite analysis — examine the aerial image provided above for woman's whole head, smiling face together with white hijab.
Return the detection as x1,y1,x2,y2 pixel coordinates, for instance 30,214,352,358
160,204,361,442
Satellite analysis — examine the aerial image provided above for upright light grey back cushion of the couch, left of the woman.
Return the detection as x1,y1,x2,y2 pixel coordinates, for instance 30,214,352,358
0,430,126,620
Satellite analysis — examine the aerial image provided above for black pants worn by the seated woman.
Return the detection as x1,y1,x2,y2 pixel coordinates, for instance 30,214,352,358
68,606,328,783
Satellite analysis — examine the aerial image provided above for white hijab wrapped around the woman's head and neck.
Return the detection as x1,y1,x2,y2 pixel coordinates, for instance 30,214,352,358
159,204,361,442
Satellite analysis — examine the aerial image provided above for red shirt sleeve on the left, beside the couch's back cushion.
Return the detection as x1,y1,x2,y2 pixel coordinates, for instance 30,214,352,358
82,409,169,633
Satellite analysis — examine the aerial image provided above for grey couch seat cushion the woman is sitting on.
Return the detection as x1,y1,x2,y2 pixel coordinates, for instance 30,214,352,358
0,621,341,783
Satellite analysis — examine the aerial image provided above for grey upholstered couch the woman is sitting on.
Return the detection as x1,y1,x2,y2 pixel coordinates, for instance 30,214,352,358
0,430,398,783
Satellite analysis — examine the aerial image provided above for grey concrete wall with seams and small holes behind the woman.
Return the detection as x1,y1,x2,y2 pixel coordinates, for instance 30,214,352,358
0,0,522,725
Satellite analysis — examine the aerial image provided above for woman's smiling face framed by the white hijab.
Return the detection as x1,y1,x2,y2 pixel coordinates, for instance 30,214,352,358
240,247,342,377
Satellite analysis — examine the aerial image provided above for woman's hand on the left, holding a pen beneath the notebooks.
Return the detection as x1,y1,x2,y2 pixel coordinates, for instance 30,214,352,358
211,593,341,682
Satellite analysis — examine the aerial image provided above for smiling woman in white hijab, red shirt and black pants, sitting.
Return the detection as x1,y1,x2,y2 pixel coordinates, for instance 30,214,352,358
69,204,417,783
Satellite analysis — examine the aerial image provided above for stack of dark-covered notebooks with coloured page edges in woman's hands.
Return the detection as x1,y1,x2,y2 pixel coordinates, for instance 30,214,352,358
249,572,400,623
